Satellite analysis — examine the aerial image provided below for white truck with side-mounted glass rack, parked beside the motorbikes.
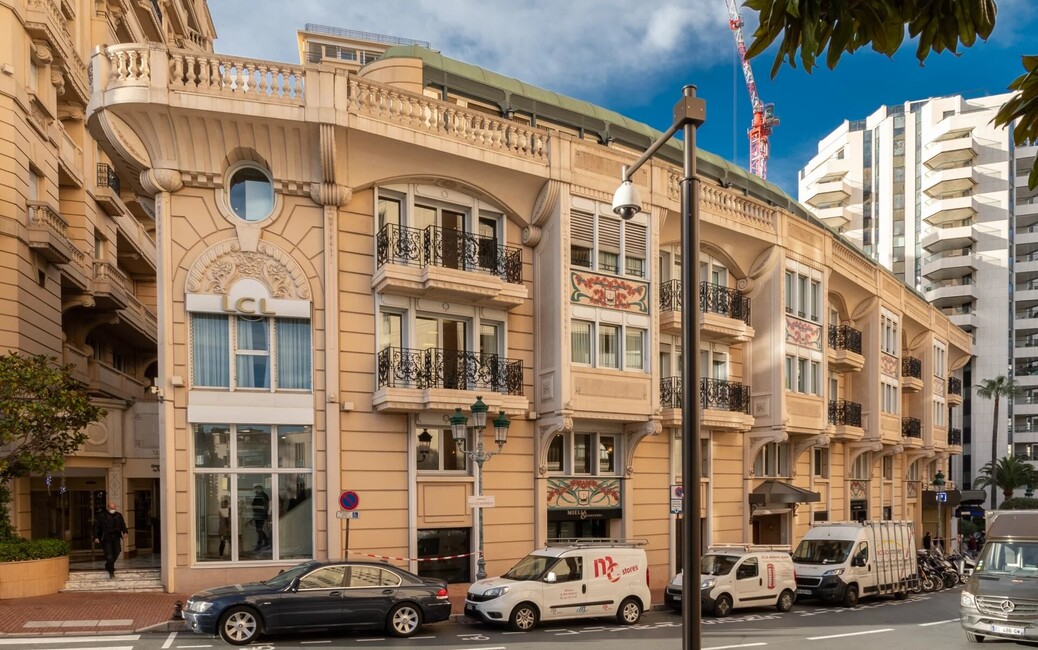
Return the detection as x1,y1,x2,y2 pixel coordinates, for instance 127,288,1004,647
793,521,917,607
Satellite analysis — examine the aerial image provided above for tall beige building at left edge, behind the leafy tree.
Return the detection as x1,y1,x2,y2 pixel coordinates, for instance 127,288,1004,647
0,0,215,567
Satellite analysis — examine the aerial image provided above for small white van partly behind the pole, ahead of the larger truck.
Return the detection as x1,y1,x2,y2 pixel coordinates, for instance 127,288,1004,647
663,544,796,617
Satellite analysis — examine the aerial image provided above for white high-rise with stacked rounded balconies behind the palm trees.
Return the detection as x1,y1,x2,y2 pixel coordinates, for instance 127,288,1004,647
799,94,1038,496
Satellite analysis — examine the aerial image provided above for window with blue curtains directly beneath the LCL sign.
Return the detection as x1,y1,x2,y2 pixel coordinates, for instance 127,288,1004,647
191,314,313,390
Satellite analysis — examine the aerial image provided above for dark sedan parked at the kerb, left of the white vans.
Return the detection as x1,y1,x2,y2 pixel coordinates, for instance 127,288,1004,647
184,560,450,646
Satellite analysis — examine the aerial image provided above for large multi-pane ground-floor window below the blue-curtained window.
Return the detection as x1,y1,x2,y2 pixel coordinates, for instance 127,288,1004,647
192,424,313,562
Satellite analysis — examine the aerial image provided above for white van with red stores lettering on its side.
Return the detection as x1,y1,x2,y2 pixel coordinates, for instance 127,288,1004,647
465,539,652,631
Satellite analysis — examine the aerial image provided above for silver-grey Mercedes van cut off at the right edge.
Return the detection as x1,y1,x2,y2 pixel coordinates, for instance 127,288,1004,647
959,510,1038,643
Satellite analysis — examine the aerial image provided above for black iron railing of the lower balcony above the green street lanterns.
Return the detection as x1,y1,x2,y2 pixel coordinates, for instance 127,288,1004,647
378,348,523,396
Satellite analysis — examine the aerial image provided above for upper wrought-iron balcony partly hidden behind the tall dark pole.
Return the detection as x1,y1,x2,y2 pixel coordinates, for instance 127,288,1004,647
659,279,754,345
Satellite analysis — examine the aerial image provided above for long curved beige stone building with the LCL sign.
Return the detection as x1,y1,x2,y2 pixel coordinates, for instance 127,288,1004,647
8,11,971,592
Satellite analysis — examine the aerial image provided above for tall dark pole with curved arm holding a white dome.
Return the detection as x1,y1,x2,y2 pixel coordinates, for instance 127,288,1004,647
612,85,707,650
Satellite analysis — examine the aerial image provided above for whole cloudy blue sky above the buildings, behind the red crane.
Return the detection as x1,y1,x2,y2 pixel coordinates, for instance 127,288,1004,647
210,0,1038,198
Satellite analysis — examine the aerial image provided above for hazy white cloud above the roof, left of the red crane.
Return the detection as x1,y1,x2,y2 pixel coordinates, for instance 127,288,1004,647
210,0,734,101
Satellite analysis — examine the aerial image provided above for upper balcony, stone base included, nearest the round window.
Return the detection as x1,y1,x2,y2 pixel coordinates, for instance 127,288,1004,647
372,223,527,308
